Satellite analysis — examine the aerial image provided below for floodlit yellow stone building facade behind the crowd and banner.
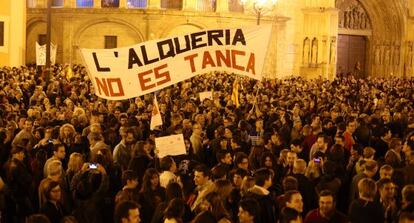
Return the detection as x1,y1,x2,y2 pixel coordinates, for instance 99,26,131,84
26,0,414,78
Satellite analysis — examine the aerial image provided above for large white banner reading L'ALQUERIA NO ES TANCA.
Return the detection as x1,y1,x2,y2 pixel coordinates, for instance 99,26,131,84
81,25,271,100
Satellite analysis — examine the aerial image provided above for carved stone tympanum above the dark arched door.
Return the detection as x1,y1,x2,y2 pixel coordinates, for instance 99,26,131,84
336,0,371,30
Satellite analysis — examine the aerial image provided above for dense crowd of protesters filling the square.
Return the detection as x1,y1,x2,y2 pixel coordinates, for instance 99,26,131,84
0,65,414,223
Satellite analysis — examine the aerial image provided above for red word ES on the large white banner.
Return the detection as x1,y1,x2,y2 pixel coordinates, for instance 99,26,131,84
138,64,171,91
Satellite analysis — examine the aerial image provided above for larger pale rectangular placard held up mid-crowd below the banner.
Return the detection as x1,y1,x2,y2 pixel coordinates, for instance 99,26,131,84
155,134,186,158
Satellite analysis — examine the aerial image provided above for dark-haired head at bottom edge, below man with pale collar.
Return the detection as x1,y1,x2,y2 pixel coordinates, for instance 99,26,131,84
237,199,260,223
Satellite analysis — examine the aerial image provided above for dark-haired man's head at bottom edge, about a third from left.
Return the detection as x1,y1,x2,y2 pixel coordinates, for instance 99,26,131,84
114,200,141,223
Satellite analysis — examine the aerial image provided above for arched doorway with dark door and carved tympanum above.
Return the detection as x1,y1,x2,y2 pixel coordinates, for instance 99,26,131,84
336,0,372,77
